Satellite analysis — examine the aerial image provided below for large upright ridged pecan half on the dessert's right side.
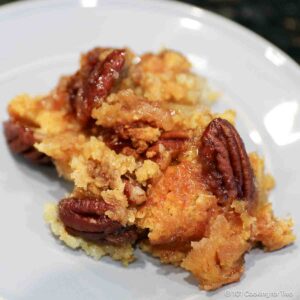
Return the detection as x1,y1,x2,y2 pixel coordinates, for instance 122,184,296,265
199,118,255,201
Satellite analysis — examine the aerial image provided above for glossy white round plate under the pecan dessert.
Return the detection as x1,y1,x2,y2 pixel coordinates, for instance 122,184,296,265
0,0,300,300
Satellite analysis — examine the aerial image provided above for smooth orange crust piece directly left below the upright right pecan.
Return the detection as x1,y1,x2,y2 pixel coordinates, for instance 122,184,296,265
137,162,218,245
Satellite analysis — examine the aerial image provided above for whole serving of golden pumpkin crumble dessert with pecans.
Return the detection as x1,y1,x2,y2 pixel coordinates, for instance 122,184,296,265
4,48,295,290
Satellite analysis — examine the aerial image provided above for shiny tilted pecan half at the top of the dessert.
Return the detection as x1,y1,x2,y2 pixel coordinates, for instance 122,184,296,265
71,49,125,125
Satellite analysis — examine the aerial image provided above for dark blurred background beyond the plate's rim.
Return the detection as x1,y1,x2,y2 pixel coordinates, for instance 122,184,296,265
0,0,300,63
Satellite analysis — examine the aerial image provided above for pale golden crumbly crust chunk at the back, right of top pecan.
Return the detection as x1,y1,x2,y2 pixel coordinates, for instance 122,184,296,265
122,50,216,105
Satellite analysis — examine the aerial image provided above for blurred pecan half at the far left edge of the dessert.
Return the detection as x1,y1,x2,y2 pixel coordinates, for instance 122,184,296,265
3,120,51,165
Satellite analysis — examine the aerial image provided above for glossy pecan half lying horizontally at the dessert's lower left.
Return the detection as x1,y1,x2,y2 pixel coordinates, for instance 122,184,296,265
58,197,138,245
